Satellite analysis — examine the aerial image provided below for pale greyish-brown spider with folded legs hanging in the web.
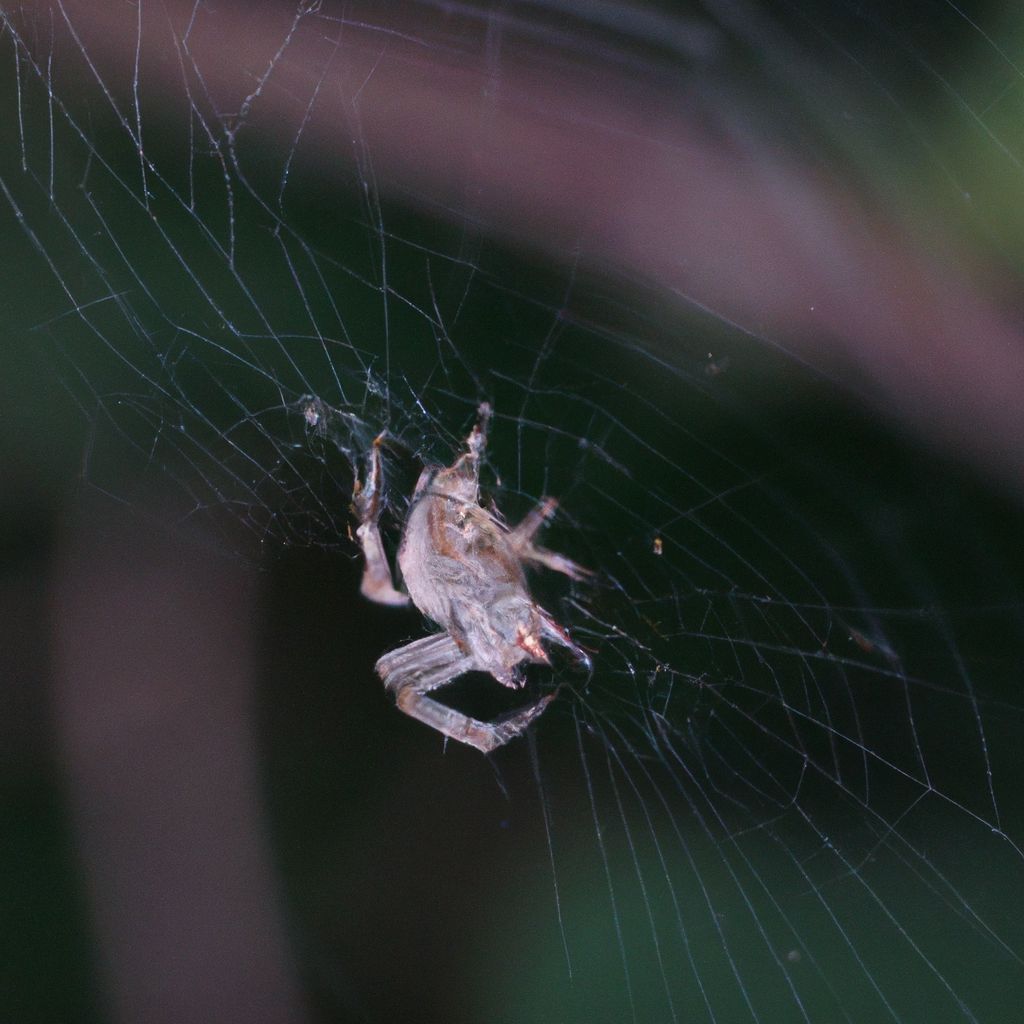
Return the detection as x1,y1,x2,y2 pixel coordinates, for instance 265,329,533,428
352,403,592,754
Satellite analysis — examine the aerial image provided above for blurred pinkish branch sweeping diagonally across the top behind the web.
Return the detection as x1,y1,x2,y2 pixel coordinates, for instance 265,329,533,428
8,0,1024,490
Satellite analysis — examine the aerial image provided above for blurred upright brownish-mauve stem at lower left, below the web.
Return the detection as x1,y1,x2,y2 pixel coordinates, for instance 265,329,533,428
53,505,304,1024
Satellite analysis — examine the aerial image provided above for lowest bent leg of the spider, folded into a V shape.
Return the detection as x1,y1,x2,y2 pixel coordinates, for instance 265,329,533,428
377,633,555,754
